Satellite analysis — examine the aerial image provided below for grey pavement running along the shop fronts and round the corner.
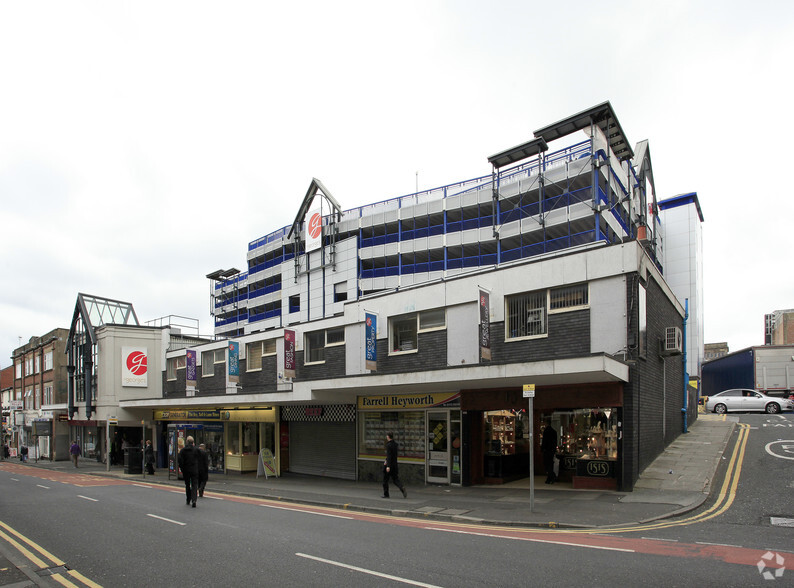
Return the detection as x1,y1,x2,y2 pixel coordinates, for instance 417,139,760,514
1,414,738,529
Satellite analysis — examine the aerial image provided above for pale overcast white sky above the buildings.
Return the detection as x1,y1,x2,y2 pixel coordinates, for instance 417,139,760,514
0,0,794,367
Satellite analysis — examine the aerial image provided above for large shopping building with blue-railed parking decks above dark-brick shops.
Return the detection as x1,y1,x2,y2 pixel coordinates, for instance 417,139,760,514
121,103,696,490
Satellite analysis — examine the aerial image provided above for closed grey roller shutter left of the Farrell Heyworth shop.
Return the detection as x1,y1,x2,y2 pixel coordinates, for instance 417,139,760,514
289,421,356,480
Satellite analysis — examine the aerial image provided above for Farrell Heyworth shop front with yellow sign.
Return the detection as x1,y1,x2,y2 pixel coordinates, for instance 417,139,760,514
358,392,463,485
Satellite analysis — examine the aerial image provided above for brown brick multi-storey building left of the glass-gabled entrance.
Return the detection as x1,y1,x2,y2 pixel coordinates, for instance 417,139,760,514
9,329,69,460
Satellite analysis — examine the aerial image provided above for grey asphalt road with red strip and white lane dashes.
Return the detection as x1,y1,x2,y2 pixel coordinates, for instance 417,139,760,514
0,414,794,587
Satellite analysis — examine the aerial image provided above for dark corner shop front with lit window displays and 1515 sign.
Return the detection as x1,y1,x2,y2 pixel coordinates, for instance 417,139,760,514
461,384,623,490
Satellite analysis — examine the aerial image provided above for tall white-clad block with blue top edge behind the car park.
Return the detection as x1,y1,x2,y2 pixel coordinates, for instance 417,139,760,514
659,192,705,381
